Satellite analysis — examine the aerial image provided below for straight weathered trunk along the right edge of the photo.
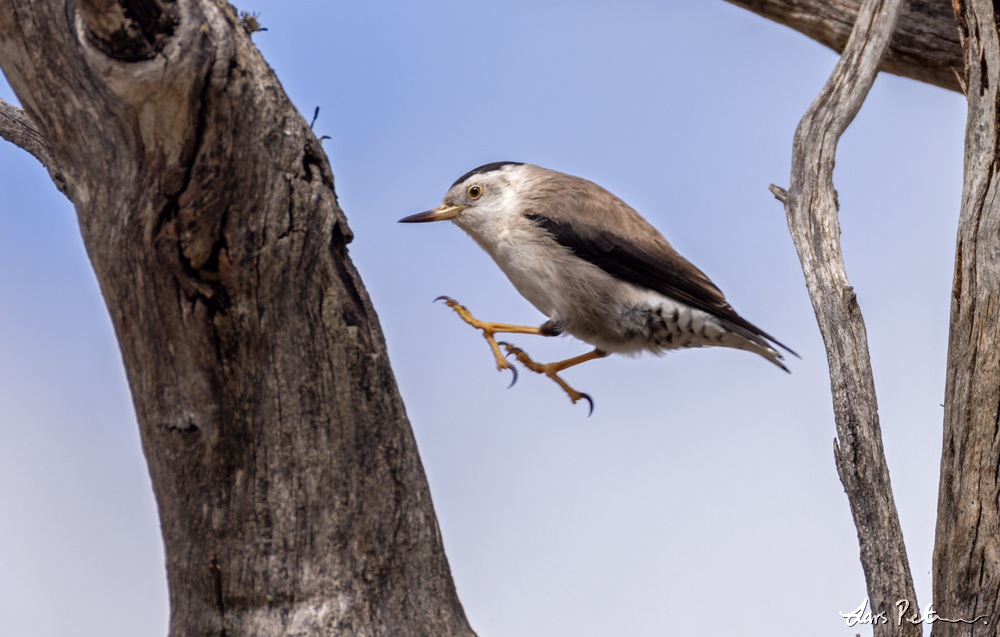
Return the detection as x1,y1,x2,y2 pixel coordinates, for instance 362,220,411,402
933,0,1000,637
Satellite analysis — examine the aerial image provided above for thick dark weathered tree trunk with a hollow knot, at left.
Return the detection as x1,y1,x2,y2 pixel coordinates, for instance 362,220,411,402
0,0,473,637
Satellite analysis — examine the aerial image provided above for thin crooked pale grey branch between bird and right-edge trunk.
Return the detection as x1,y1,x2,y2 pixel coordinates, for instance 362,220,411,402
771,0,921,637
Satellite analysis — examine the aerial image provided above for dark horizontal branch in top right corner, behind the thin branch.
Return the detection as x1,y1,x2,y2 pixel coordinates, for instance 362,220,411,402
729,0,964,92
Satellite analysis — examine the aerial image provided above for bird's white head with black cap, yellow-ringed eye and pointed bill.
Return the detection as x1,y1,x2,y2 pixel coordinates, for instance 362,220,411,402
399,161,531,233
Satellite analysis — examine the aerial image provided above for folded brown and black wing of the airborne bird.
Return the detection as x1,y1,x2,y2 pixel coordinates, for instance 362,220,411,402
525,176,797,356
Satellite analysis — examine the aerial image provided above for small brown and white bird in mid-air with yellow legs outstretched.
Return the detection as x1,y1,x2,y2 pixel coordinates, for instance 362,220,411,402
399,161,798,413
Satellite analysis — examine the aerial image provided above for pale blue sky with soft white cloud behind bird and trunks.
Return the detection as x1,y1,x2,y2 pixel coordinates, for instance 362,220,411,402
0,0,965,637
